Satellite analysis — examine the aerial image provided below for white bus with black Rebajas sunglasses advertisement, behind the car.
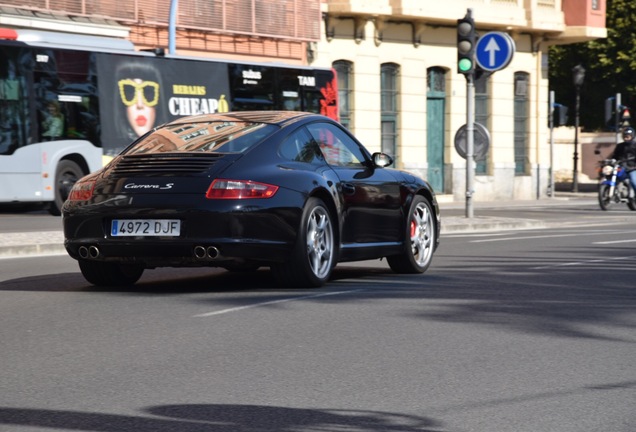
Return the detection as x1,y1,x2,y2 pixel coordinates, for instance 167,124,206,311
0,29,338,215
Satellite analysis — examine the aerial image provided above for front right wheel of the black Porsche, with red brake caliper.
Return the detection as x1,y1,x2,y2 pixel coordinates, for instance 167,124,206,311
387,195,437,273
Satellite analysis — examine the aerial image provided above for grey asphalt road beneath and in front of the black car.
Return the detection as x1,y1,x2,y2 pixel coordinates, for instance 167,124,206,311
0,221,636,432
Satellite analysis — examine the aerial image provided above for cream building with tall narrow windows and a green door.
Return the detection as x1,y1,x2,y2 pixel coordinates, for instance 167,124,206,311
315,0,606,200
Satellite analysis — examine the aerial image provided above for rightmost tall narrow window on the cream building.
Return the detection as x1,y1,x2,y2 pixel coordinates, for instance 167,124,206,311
514,72,530,175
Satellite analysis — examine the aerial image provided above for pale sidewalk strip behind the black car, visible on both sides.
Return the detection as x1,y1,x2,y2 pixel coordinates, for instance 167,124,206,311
0,192,596,259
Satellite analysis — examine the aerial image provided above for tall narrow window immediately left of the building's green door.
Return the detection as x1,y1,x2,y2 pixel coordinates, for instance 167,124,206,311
380,63,400,167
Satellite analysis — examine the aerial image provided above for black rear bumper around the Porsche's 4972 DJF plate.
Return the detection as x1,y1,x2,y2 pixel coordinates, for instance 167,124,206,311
63,196,301,267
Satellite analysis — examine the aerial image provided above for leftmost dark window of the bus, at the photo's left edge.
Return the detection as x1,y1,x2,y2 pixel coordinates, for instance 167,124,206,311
0,46,30,155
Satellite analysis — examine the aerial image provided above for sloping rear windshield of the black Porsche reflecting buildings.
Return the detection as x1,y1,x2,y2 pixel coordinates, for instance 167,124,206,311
124,121,278,155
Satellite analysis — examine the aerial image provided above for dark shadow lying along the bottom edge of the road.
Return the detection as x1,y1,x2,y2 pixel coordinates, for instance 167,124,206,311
0,404,441,432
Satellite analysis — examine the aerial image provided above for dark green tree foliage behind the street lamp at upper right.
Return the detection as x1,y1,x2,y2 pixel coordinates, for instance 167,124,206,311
548,0,636,130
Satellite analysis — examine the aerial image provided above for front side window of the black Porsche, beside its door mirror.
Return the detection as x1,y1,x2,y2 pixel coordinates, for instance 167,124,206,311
307,123,365,167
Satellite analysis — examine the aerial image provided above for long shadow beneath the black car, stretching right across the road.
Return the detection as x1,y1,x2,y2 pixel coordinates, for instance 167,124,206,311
0,254,636,343
